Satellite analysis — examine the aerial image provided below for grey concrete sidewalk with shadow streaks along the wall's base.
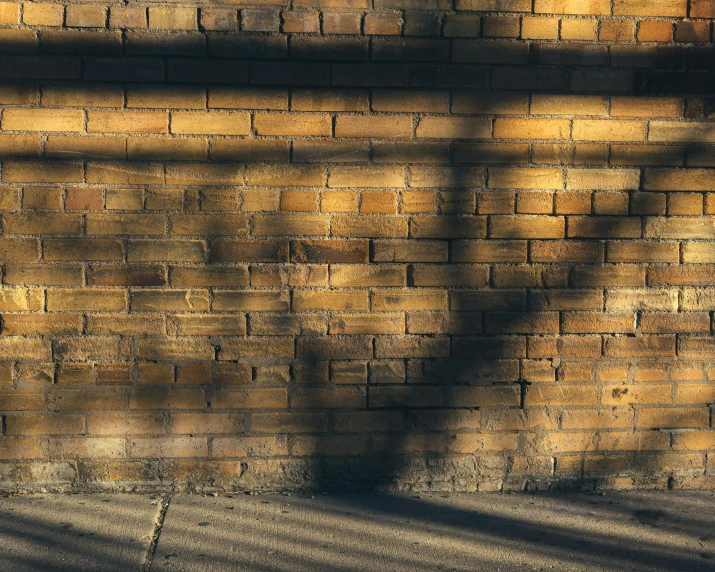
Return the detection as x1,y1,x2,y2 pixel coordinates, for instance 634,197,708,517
0,492,715,572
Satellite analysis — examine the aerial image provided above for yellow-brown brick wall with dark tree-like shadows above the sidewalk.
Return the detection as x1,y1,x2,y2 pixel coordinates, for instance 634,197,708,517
0,0,715,490
